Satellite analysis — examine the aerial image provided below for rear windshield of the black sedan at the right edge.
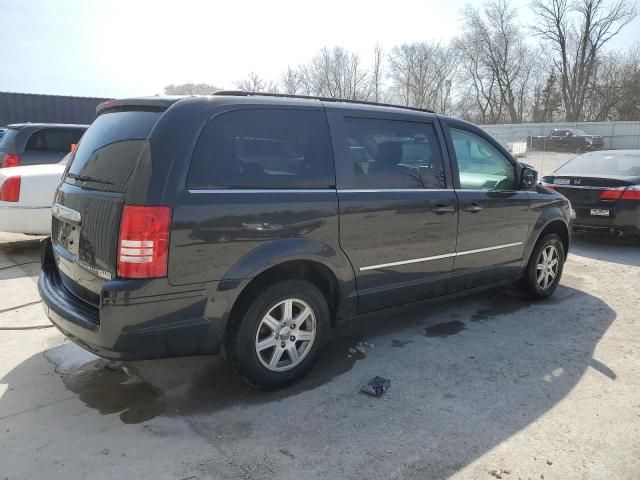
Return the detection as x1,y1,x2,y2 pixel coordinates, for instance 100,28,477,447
555,151,640,176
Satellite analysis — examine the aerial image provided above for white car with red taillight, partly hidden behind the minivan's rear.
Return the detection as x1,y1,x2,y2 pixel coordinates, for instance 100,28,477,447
0,155,68,235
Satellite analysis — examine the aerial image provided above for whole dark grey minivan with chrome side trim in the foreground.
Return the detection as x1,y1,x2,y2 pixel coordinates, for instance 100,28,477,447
39,92,570,386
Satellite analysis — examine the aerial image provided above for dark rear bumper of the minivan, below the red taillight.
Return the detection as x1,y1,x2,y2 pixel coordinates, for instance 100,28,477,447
38,238,232,360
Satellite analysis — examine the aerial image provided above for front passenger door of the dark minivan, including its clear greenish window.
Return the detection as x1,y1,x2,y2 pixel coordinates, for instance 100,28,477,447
449,124,529,288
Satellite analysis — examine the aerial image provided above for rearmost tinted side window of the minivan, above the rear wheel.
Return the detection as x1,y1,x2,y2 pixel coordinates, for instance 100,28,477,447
187,109,335,189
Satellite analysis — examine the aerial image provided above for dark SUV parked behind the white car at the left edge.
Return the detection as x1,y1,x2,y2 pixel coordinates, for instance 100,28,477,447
0,123,88,168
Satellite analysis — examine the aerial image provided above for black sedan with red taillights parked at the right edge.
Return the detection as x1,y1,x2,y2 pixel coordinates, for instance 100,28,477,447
542,150,640,238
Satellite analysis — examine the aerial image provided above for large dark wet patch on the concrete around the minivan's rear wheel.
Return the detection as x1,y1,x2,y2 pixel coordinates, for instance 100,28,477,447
45,331,366,423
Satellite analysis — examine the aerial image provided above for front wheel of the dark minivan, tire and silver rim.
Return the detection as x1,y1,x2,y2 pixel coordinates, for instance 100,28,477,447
517,233,566,300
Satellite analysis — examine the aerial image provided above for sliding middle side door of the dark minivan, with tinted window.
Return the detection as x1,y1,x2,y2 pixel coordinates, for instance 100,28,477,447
329,111,458,312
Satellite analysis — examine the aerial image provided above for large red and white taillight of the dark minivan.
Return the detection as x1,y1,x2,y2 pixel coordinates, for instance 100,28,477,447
118,205,171,278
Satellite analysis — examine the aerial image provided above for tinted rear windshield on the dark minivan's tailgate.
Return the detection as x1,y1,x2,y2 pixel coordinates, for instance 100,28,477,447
65,111,162,192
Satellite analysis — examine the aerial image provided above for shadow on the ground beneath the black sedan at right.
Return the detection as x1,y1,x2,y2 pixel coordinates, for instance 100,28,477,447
569,232,640,267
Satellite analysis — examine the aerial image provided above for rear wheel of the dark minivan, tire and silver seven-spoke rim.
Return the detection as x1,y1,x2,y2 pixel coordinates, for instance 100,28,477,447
225,280,330,388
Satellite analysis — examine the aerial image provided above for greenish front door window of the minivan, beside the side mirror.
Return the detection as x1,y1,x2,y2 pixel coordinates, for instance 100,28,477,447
450,128,516,190
